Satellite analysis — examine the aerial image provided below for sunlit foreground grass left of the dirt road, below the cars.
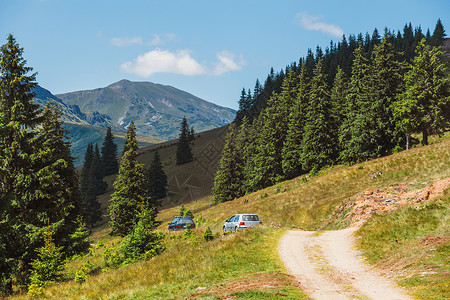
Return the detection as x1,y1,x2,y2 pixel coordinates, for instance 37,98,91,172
14,227,304,299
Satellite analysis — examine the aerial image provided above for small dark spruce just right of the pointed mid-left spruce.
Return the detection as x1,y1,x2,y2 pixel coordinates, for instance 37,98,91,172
147,151,167,209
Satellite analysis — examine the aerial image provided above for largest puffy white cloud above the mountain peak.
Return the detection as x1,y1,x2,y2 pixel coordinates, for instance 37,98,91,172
120,49,206,77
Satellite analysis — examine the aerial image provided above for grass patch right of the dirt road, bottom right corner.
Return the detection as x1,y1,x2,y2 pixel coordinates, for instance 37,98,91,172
357,189,450,299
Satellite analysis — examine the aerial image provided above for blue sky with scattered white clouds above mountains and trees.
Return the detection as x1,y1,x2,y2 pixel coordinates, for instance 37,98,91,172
0,0,450,109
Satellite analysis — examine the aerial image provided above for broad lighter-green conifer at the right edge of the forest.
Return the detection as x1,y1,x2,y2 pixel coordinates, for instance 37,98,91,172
395,39,450,148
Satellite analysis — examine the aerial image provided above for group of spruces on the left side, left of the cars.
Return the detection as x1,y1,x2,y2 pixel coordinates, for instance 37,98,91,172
0,35,198,296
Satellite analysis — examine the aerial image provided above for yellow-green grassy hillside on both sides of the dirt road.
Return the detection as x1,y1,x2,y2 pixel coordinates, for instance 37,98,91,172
12,131,450,299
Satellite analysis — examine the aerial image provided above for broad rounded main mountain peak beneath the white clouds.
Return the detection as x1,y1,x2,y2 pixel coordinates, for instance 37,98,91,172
56,80,236,140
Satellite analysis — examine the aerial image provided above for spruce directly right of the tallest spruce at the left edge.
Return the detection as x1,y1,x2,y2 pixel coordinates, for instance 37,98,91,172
37,104,89,256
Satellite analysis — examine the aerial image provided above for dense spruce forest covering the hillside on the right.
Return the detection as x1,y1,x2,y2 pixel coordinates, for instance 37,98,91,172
212,20,450,204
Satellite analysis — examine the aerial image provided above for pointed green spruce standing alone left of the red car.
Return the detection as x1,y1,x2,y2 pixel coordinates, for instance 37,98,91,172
109,122,156,236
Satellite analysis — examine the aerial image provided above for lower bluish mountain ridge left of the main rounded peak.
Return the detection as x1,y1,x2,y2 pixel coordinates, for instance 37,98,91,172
33,85,164,166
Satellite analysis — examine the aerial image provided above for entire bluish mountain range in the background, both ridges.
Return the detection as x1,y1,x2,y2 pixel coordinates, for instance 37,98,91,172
34,80,236,166
